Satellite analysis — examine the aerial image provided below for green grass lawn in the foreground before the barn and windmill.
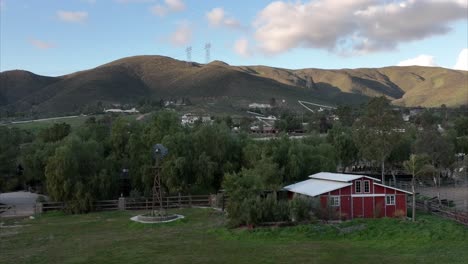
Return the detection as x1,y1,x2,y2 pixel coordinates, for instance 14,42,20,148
0,209,468,264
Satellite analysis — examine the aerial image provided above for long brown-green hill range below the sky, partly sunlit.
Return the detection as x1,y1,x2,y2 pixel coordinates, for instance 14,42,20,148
0,56,468,113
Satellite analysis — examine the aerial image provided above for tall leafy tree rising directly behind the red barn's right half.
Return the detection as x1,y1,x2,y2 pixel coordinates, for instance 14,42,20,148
353,96,403,183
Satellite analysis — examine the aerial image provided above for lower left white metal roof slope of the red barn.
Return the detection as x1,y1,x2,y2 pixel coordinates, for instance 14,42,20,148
284,179,352,196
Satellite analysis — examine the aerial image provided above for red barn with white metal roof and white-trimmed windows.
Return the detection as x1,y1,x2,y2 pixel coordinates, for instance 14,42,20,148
284,172,411,219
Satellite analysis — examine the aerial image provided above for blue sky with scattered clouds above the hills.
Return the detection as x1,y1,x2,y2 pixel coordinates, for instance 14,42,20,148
0,0,468,76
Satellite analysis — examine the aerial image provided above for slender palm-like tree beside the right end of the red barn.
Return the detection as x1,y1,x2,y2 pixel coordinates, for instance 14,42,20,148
403,154,433,222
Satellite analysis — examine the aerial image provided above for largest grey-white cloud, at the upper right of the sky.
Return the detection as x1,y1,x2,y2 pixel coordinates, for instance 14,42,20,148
253,0,468,55
